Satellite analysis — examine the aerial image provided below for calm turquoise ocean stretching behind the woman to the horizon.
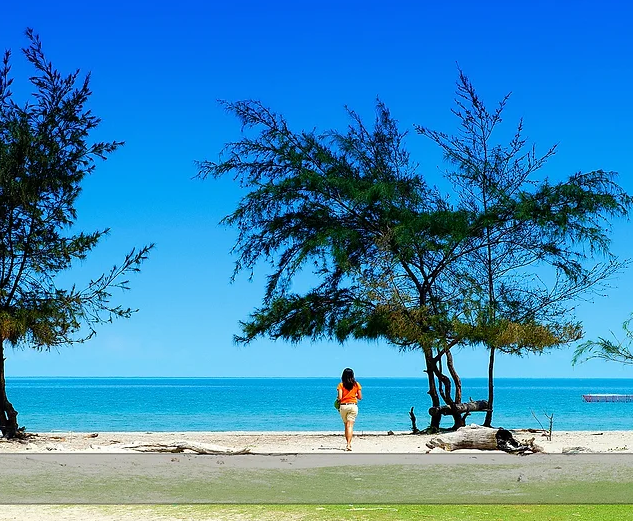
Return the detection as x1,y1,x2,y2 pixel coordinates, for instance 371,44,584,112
7,378,633,432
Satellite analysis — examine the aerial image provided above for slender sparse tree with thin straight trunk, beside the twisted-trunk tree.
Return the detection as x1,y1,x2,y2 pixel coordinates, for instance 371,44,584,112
416,70,631,426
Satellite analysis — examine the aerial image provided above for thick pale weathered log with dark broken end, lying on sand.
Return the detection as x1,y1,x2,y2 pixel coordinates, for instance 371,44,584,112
426,425,543,454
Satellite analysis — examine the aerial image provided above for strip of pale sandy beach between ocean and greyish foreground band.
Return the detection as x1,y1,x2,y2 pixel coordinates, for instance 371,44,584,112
0,429,633,454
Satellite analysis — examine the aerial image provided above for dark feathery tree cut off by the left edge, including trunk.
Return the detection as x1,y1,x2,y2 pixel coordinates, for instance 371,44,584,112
0,29,152,438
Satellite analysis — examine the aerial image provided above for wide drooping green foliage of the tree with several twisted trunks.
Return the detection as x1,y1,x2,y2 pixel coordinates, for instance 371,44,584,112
200,101,477,348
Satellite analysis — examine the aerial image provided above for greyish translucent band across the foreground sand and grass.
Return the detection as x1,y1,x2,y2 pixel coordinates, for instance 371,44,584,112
0,452,633,504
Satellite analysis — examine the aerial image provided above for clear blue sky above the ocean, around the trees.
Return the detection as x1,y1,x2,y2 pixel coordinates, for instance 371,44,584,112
0,0,633,377
